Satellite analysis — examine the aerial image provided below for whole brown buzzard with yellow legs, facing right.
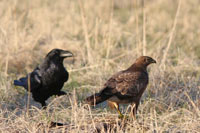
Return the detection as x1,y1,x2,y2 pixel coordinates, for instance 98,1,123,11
85,56,156,118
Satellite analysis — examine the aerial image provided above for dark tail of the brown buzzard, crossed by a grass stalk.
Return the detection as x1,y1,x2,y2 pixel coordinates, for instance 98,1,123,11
85,93,111,106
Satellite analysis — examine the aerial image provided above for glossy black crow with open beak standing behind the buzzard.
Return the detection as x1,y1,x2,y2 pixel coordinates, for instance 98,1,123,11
14,49,73,107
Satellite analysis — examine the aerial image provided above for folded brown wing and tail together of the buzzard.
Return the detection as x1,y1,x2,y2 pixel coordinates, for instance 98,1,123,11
86,71,148,105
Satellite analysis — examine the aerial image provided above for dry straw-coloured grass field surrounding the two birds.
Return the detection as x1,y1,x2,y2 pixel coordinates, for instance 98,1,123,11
0,0,200,133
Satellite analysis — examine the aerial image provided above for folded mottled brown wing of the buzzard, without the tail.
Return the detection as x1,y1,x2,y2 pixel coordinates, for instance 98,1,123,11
104,71,148,96
